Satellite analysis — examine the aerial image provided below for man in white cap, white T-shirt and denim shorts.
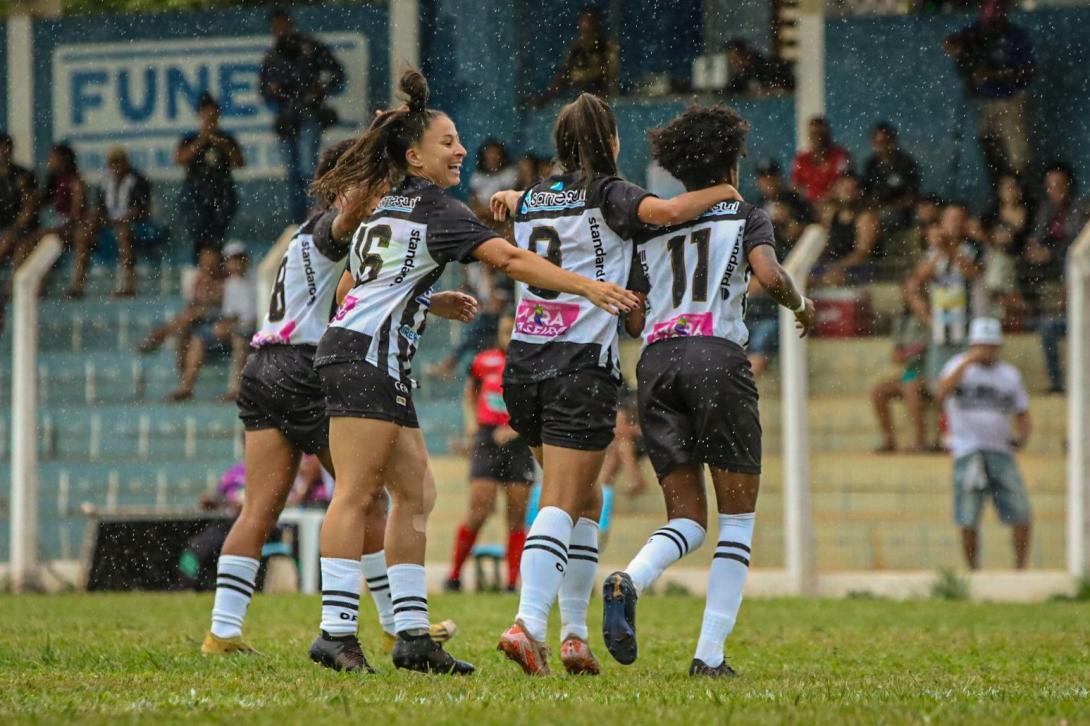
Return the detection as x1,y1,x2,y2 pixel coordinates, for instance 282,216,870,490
935,317,1031,569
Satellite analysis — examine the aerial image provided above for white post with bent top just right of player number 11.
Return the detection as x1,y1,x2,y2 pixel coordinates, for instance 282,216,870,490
779,225,828,595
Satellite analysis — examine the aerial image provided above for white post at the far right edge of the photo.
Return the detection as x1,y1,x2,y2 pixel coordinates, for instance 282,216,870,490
1067,223,1090,578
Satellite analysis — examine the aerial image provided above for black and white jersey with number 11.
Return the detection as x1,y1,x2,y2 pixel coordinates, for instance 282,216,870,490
632,202,775,347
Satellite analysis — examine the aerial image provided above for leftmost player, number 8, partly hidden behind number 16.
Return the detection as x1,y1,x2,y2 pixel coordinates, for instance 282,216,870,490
201,135,473,655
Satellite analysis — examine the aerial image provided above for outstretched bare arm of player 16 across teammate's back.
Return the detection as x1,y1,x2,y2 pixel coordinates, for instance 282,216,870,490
473,237,639,315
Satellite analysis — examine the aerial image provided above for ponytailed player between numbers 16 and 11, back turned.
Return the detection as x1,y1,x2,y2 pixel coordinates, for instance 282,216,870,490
494,94,738,675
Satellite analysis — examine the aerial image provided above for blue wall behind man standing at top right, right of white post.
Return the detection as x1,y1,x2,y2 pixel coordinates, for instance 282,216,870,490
826,9,1090,208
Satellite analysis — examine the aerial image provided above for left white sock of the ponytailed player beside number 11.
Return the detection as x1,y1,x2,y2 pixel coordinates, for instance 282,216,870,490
518,507,572,641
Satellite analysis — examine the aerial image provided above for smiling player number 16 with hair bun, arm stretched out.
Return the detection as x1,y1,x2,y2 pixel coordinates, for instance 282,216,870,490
311,71,635,674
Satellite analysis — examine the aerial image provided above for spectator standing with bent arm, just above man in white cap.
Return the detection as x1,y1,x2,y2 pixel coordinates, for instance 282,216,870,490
905,202,983,385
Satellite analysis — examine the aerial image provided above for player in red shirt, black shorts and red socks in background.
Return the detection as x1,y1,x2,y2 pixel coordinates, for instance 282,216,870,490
446,315,534,592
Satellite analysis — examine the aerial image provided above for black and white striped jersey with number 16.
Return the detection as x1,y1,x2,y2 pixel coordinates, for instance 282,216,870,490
314,177,496,384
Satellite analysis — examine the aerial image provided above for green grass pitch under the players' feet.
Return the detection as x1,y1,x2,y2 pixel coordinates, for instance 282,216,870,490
0,594,1090,726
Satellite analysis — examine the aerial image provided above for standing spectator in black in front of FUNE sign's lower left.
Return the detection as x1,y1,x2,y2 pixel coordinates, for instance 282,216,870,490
174,94,246,261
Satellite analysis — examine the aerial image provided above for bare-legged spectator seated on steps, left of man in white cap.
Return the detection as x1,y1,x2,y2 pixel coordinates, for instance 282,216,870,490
871,301,931,453
